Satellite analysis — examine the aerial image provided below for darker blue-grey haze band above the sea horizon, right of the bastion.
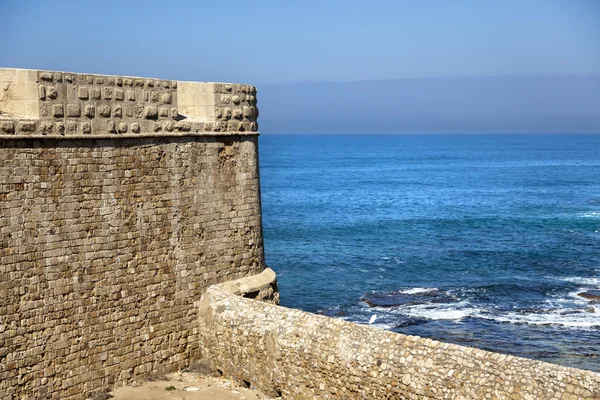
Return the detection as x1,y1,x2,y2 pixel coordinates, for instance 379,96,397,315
258,76,600,133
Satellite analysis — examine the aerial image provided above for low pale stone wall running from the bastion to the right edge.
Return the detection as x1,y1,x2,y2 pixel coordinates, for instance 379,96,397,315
198,286,600,400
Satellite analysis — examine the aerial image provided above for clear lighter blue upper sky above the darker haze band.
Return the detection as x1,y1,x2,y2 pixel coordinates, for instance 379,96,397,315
0,0,600,84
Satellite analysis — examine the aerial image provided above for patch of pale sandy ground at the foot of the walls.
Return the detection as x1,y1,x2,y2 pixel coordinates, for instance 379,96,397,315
106,372,272,400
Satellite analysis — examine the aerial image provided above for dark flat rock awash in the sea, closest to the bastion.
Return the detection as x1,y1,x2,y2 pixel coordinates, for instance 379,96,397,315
360,290,459,307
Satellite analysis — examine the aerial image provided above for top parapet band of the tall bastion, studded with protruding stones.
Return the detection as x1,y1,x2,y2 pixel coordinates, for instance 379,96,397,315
0,68,258,139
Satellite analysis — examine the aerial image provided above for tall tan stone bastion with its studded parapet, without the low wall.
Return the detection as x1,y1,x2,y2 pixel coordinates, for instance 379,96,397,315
0,69,265,399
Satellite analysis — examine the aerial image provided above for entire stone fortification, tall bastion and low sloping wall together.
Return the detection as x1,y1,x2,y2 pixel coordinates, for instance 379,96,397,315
0,69,600,400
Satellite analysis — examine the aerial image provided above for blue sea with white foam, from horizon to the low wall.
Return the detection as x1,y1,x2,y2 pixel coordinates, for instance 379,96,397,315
260,134,600,371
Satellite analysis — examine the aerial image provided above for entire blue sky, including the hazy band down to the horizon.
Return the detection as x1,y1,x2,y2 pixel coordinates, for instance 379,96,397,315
0,0,600,133
